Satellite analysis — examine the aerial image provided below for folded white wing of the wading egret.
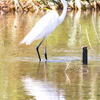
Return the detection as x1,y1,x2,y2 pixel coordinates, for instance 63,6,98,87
21,11,59,45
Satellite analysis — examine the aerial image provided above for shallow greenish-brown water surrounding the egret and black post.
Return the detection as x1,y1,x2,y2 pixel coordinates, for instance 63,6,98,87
0,11,100,100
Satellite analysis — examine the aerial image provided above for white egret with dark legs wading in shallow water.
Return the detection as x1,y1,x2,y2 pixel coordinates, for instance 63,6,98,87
20,0,67,61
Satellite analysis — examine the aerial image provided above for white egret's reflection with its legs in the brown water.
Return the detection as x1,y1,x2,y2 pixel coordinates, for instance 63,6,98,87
22,61,65,100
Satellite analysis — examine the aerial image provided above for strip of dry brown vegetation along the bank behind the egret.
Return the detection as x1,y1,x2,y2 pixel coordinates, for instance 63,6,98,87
0,0,100,12
